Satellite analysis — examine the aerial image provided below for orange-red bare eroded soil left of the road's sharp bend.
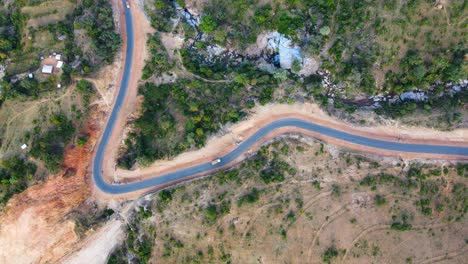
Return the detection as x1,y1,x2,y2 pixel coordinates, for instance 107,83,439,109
0,109,98,263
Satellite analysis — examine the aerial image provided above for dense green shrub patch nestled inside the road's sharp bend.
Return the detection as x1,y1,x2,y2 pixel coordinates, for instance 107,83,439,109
118,73,274,168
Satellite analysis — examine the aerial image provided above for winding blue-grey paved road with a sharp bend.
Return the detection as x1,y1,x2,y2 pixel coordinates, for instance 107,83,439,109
93,5,468,194
